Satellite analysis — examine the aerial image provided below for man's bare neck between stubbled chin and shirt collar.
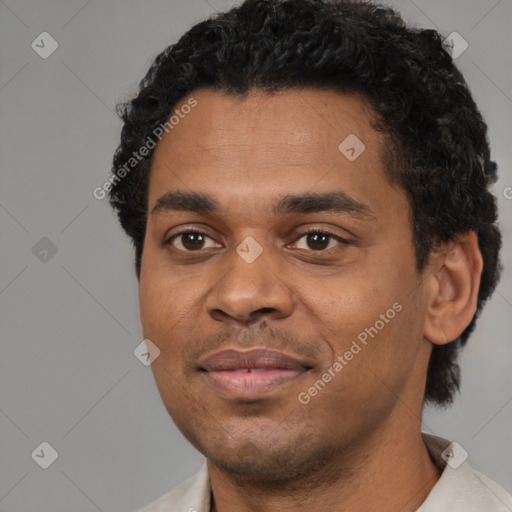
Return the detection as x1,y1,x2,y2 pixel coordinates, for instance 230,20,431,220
207,418,440,512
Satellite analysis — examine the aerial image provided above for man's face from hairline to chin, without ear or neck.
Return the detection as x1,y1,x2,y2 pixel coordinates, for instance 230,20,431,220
139,90,430,481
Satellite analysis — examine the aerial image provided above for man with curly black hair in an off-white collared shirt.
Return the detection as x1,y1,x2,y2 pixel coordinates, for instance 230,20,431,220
110,0,512,512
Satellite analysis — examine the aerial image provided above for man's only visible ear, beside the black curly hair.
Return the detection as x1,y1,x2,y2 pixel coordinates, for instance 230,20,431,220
423,231,483,345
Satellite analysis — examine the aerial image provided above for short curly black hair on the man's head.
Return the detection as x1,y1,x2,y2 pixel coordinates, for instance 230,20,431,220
109,0,501,406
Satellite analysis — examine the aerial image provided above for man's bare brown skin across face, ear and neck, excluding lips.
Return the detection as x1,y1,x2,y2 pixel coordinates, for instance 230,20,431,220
139,89,482,512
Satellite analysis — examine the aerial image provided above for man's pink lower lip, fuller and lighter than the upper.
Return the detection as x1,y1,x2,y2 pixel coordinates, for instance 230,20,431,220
203,368,306,399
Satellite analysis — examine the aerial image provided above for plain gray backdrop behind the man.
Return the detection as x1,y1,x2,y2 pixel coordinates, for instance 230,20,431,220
0,0,512,512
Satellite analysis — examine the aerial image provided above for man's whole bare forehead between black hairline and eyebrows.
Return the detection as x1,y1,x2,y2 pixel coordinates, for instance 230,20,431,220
148,89,402,221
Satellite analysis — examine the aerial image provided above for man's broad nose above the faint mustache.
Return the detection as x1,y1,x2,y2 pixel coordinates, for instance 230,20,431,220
206,244,294,327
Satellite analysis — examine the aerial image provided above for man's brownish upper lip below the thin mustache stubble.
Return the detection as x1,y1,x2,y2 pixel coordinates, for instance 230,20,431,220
199,348,310,372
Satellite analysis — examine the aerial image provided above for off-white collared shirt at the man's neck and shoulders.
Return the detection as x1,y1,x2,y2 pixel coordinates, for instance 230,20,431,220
139,432,512,512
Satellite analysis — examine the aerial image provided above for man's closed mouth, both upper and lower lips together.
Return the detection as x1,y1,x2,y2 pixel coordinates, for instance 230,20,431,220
198,349,311,400
